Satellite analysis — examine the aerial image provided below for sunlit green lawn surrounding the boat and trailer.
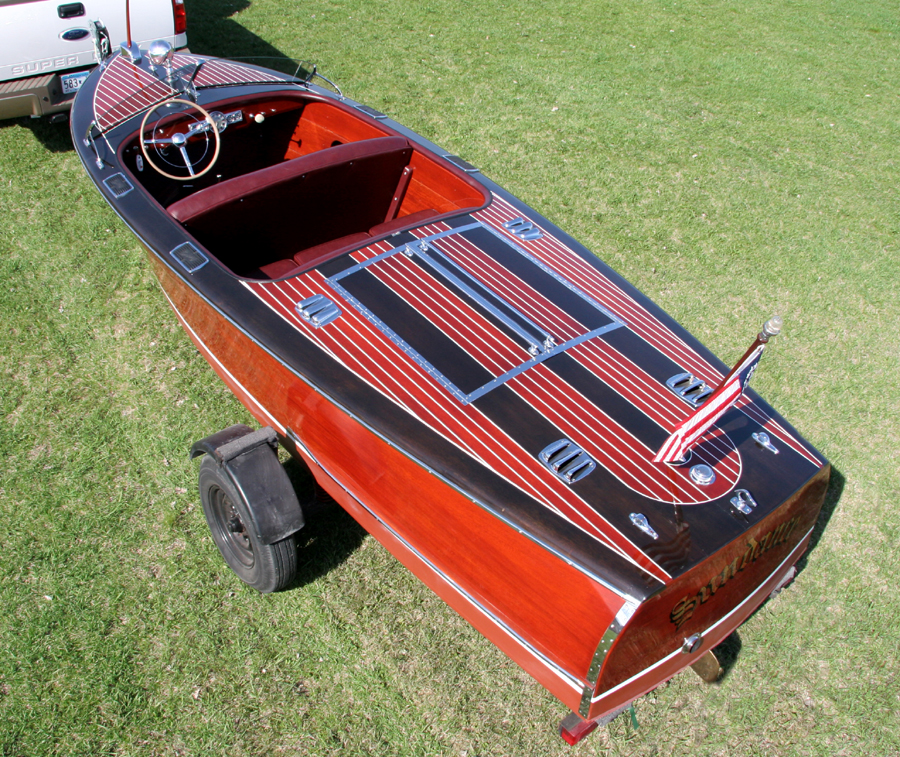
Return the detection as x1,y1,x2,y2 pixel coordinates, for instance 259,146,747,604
0,0,900,757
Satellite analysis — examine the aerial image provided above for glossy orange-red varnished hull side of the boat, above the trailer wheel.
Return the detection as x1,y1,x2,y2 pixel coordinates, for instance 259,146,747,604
152,256,623,704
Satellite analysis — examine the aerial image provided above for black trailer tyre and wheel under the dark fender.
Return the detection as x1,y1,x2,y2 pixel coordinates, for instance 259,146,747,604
199,455,297,593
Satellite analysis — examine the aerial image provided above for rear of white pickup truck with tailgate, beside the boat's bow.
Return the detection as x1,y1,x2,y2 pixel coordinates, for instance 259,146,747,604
0,0,187,120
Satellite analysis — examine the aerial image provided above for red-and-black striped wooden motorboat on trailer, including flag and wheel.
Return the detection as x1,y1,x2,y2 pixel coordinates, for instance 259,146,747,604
72,46,829,742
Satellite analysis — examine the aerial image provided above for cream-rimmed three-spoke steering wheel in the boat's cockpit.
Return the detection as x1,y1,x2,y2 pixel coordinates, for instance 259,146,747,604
140,98,221,181
